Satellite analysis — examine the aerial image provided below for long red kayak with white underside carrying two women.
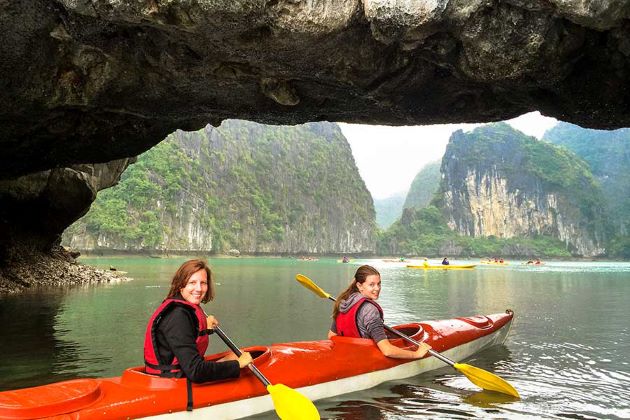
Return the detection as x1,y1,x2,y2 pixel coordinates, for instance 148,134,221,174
0,311,513,420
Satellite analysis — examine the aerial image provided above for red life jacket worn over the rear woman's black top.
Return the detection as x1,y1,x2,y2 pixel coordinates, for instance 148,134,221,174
144,299,209,378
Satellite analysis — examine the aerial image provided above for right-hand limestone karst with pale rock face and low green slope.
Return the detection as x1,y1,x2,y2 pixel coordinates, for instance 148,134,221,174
377,123,606,257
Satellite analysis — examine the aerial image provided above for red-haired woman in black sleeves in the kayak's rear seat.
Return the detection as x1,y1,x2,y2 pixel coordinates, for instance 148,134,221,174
144,260,252,409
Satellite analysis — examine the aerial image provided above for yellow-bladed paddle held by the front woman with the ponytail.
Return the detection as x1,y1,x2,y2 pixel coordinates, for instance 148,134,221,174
295,274,520,398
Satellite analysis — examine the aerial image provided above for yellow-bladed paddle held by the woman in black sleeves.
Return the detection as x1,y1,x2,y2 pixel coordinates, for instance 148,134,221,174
213,326,320,420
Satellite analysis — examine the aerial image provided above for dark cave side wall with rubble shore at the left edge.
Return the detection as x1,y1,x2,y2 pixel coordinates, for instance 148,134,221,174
0,158,134,293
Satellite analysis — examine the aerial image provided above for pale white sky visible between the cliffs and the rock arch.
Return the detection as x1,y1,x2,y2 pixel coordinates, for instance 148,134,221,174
339,112,558,199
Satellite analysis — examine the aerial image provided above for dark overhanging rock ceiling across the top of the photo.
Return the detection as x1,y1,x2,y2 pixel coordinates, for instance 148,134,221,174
0,0,630,179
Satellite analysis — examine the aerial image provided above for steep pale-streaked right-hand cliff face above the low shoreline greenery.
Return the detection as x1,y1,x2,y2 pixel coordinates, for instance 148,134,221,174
441,124,606,256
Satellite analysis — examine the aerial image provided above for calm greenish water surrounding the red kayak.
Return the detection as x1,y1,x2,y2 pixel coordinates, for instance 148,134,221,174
0,258,630,419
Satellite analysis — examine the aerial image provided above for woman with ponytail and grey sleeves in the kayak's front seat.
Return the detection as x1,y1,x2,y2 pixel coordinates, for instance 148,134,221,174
328,265,431,359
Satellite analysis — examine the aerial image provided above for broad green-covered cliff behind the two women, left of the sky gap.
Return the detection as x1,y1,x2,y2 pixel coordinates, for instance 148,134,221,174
65,120,375,254
